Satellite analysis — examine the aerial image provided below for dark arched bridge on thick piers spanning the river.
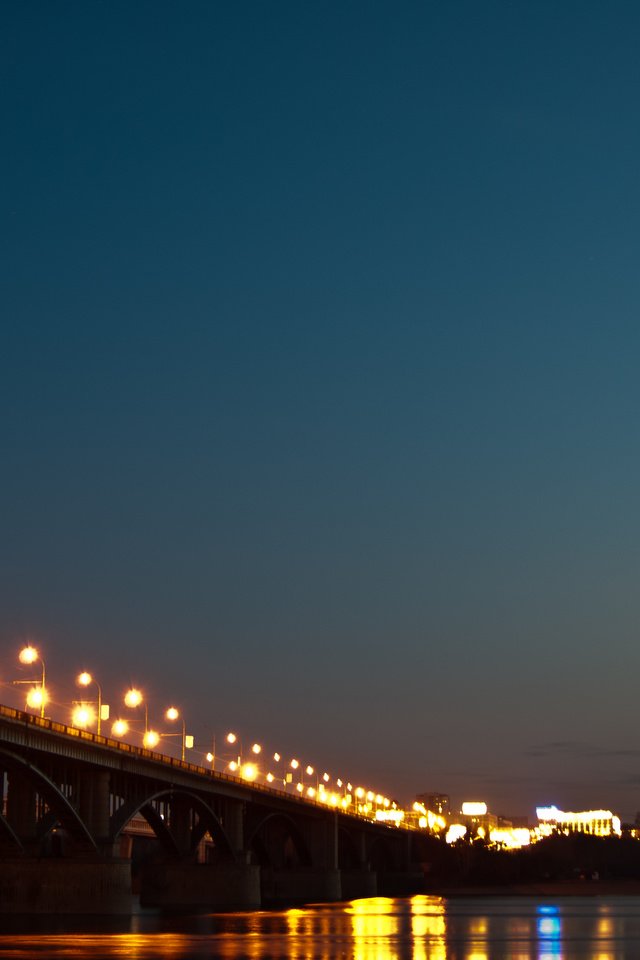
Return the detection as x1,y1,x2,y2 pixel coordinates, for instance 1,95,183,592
0,705,429,913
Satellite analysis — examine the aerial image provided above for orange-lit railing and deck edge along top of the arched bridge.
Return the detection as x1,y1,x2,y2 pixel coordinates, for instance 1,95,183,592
0,704,411,829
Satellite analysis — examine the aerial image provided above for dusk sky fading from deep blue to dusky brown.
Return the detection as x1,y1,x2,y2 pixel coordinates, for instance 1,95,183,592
0,0,640,818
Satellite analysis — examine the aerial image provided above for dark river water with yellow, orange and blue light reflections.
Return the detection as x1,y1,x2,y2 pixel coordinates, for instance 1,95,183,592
0,896,640,960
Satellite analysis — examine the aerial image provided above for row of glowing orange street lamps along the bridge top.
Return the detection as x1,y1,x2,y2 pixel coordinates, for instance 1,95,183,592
14,644,397,817
